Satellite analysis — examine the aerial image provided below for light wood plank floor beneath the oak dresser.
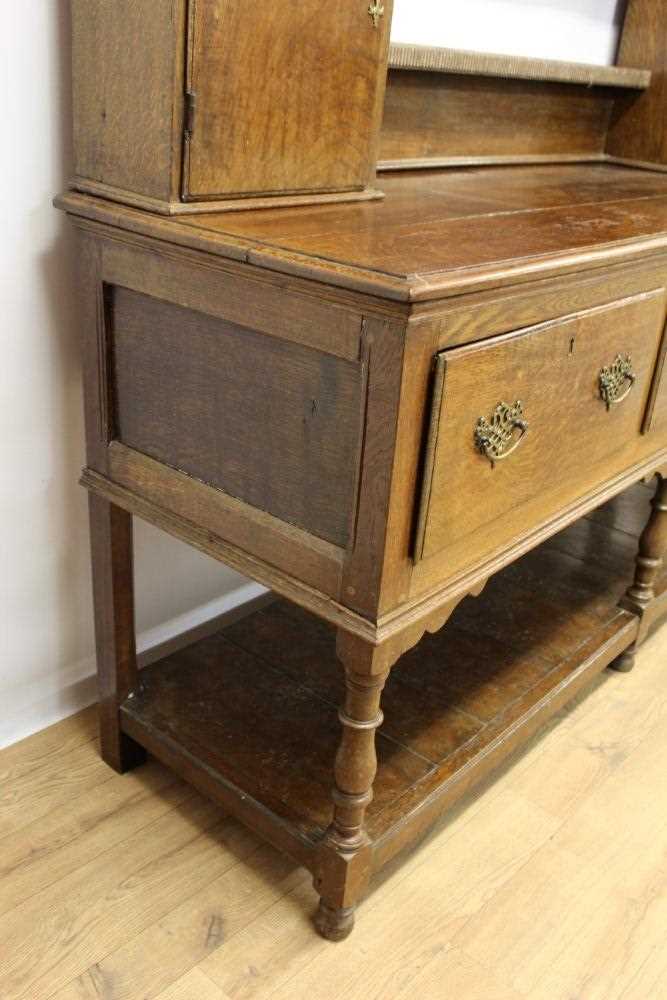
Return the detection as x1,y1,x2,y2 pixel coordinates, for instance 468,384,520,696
0,626,667,1000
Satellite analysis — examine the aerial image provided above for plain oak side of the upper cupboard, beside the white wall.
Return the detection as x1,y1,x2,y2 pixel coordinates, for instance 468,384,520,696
72,0,186,199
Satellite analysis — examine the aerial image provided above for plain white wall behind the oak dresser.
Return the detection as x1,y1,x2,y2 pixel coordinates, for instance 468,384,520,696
0,0,628,746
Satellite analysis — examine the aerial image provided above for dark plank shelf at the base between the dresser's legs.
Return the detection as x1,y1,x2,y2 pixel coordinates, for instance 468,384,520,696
121,485,667,884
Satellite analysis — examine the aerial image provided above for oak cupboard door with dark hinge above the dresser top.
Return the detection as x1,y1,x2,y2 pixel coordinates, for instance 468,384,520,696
183,0,392,200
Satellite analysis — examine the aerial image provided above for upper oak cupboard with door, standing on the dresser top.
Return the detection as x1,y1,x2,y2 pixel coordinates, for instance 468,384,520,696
72,0,392,214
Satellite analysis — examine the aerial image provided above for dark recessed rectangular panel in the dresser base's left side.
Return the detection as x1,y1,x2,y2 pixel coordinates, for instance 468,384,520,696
109,287,362,546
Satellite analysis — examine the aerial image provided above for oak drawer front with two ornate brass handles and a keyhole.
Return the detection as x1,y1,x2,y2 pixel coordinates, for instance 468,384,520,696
415,289,667,574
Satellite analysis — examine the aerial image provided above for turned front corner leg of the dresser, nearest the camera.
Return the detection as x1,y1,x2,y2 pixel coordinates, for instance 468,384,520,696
315,641,389,941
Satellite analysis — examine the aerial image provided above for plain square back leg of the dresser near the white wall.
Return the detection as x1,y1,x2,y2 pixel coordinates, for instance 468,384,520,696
89,495,146,773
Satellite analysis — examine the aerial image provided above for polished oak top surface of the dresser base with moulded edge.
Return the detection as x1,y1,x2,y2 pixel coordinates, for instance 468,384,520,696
59,163,667,301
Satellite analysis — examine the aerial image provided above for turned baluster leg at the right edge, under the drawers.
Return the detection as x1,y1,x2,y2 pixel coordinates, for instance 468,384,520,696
611,476,667,673
